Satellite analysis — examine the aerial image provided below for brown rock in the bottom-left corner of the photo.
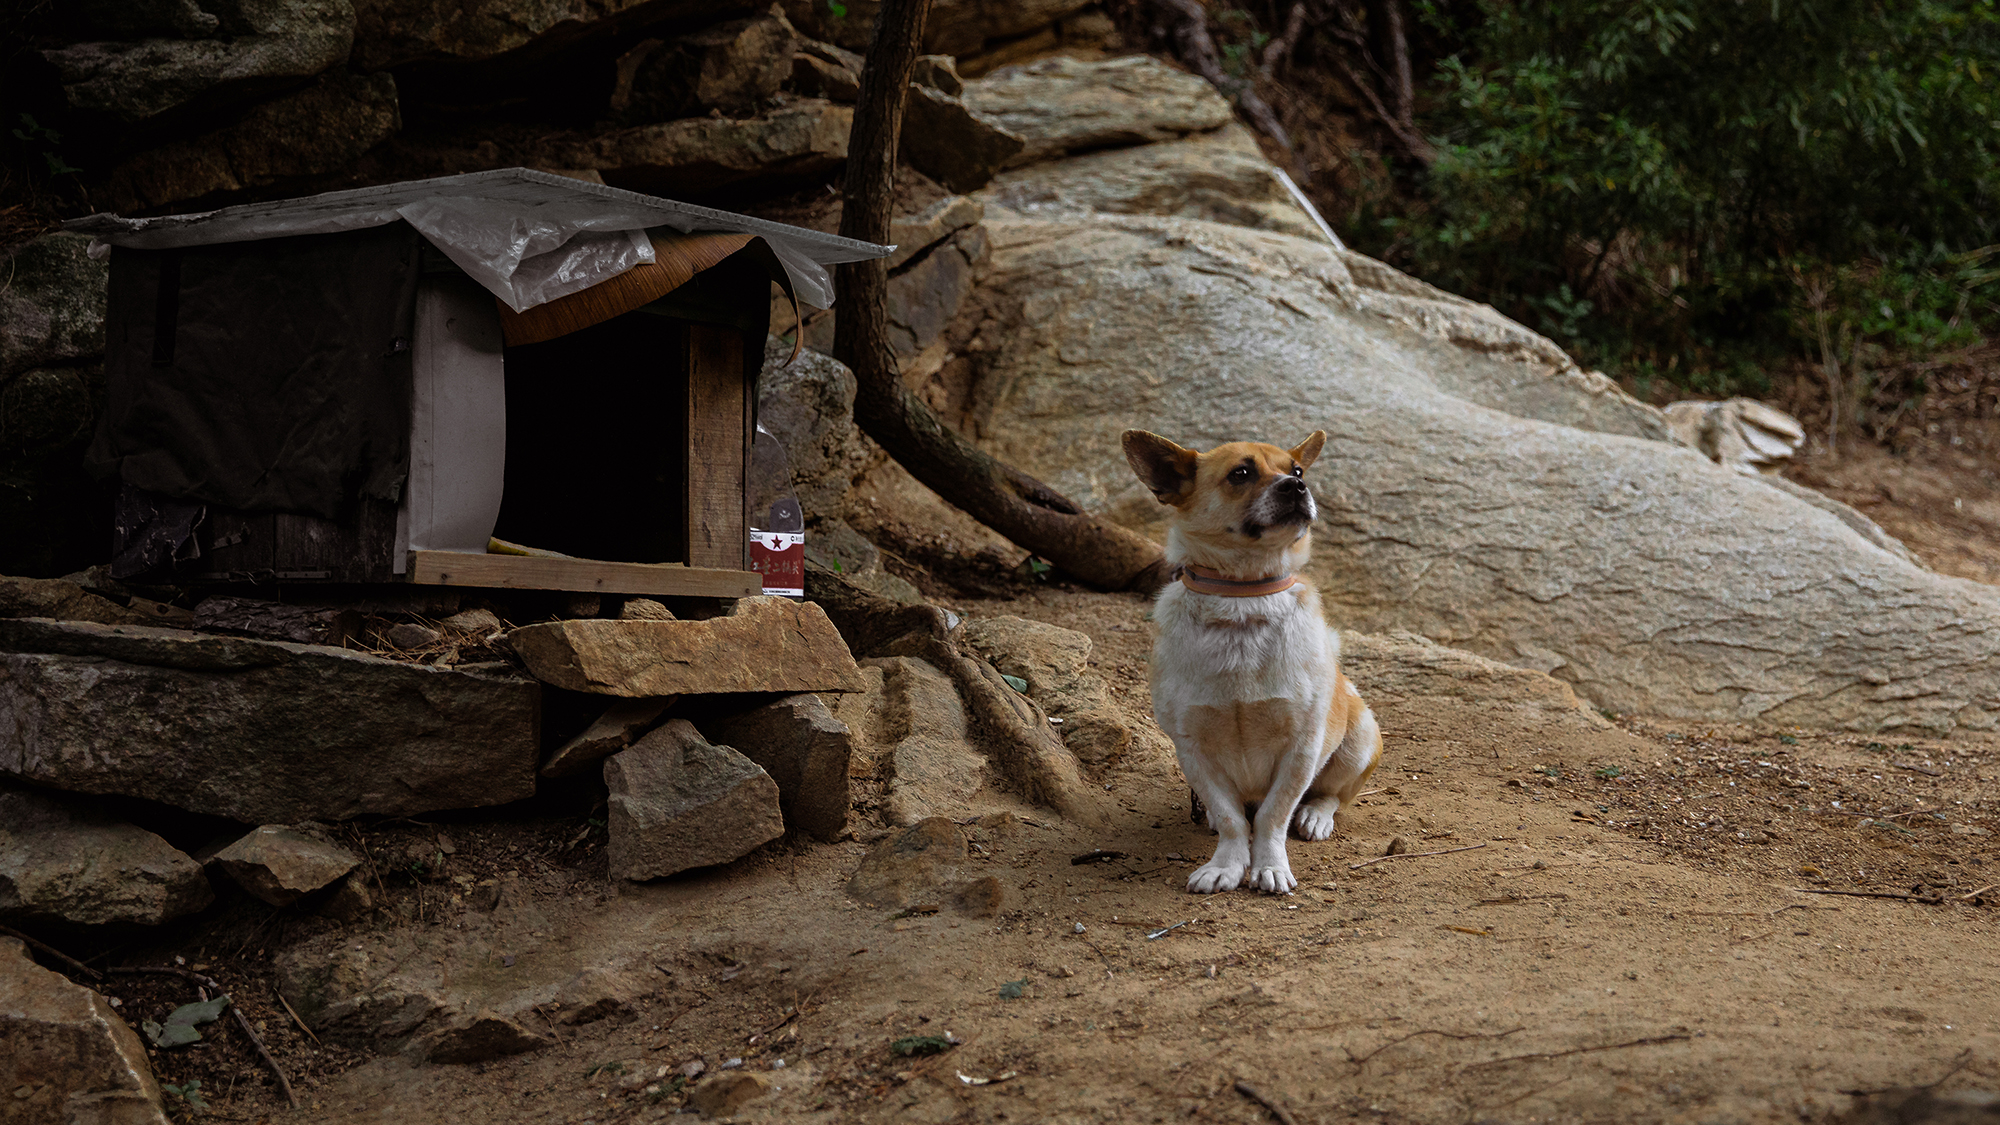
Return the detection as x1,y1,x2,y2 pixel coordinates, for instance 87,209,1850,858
0,937,168,1125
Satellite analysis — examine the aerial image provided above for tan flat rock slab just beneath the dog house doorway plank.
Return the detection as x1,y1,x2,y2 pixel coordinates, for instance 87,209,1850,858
508,597,862,697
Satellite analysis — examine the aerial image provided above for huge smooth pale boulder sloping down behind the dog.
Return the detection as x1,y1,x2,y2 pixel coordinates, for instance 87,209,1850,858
948,216,2000,733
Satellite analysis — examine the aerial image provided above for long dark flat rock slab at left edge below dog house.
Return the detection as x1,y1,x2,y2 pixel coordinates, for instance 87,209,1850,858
0,619,542,823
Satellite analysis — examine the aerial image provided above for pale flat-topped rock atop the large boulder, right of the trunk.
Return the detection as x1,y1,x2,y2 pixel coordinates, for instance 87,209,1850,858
978,122,1322,240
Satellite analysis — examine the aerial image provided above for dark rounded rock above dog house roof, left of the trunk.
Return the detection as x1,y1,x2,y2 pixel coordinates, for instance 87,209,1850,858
622,10,796,122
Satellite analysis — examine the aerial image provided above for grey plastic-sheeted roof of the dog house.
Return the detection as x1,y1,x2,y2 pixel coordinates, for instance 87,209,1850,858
64,168,894,312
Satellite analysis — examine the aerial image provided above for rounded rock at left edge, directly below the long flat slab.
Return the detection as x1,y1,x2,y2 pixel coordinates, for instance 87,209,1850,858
0,779,216,925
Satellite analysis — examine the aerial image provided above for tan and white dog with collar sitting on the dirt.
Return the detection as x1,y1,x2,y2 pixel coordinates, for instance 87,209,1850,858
1124,430,1382,895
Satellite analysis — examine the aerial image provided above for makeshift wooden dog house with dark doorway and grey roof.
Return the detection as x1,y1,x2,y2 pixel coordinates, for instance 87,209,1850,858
68,168,888,597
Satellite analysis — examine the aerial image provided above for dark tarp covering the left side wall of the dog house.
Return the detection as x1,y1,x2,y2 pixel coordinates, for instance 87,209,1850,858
90,222,422,518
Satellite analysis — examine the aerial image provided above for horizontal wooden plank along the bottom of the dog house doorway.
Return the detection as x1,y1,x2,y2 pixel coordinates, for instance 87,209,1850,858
410,550,764,599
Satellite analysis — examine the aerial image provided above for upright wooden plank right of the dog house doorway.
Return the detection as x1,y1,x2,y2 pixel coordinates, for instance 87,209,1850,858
684,324,750,571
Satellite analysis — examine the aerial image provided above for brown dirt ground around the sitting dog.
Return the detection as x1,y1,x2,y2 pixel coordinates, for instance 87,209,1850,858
54,440,2000,1125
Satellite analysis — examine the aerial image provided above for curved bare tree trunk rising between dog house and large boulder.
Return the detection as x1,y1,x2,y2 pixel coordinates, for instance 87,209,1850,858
834,0,1166,591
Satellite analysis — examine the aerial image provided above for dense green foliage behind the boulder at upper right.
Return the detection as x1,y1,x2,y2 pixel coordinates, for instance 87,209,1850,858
1356,0,2000,394
